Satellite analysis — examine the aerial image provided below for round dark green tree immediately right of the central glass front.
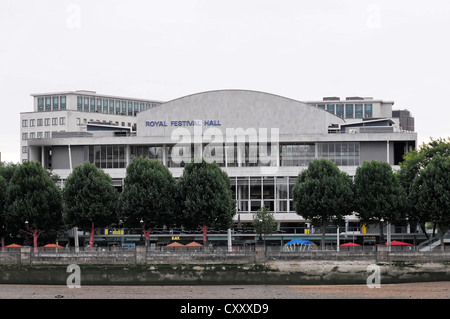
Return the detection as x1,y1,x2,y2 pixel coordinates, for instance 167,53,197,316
293,159,353,249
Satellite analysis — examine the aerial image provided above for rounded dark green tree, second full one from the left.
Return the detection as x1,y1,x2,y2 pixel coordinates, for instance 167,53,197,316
63,162,119,248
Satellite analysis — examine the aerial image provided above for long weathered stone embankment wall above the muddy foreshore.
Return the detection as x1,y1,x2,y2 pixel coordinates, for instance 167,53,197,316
0,247,450,285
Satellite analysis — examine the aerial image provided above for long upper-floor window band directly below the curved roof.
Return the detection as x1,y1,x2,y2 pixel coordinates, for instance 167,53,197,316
86,142,360,168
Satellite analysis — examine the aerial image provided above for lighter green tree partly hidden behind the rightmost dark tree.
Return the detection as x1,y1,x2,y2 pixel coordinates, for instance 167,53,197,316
398,138,450,238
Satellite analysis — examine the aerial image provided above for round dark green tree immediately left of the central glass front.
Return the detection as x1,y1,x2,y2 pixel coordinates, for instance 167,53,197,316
177,159,236,245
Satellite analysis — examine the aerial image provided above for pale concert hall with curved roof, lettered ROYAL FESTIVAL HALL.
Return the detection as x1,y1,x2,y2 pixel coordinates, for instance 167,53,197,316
21,90,417,248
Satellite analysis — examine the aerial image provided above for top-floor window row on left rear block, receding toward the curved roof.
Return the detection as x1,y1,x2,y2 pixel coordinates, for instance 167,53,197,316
77,96,159,116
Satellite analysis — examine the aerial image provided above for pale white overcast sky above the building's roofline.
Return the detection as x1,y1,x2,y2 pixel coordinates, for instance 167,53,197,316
0,0,450,162
